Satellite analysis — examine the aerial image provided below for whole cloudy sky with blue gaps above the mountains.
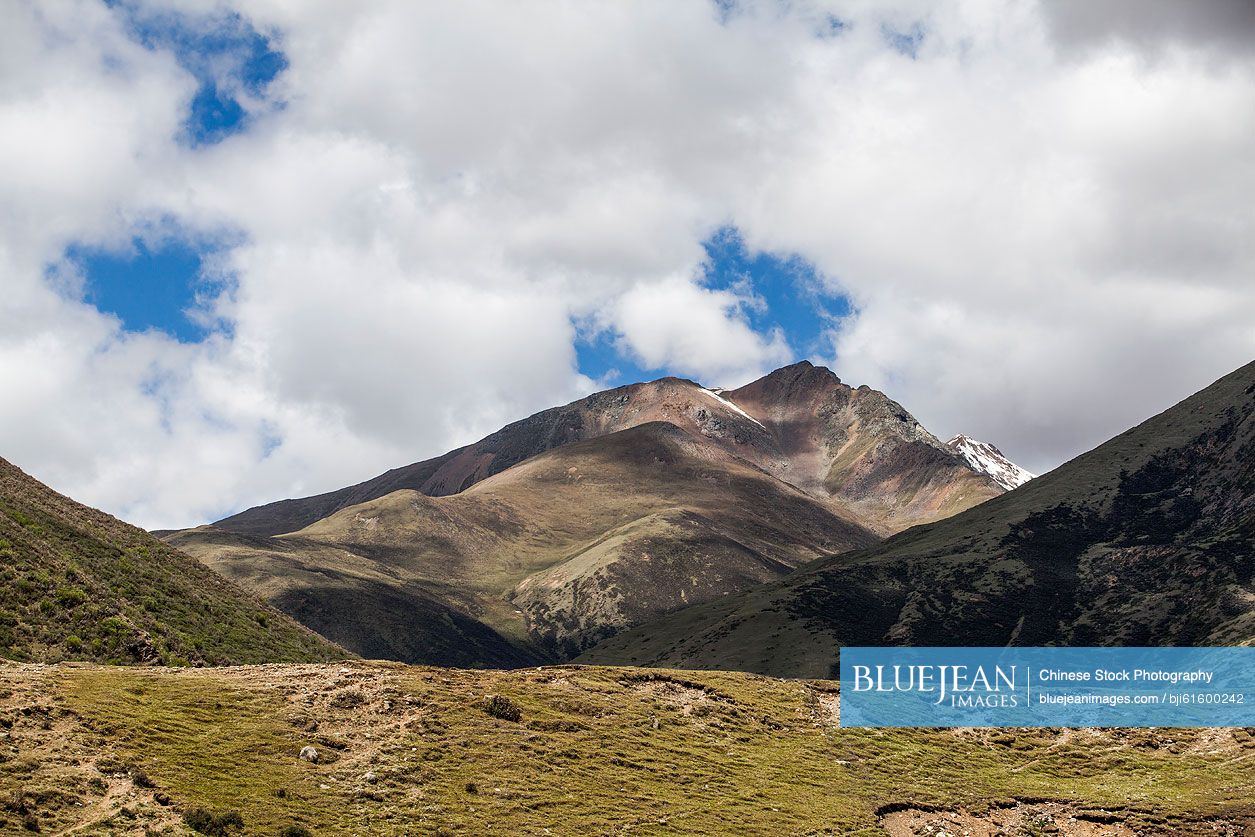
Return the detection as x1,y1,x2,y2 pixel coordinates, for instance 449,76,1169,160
0,0,1255,527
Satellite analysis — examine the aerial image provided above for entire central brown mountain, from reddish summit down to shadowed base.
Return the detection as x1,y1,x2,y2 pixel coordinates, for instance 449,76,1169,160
166,363,1001,666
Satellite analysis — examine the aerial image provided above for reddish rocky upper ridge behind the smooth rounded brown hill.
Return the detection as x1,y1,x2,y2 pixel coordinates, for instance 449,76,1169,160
215,361,1003,535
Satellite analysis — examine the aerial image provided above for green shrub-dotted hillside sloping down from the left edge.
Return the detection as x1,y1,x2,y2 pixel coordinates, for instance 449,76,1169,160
0,459,348,665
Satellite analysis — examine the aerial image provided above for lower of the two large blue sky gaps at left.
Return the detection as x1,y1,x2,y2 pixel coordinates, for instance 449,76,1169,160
65,237,229,343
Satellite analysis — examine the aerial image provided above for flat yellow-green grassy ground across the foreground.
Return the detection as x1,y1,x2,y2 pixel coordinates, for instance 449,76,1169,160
0,663,1255,834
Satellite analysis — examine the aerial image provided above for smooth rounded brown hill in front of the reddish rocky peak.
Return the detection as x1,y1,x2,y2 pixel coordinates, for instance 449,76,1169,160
171,422,876,665
